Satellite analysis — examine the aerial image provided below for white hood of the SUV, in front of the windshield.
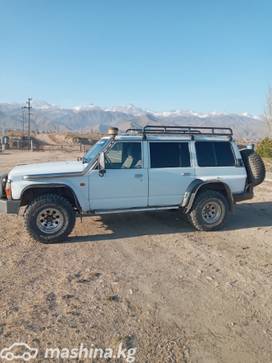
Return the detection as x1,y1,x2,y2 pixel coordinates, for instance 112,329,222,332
9,160,86,180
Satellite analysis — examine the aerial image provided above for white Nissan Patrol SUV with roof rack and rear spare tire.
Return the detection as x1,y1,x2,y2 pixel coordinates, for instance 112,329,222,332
0,126,265,243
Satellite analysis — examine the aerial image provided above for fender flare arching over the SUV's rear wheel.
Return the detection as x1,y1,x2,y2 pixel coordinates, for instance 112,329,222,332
181,179,234,213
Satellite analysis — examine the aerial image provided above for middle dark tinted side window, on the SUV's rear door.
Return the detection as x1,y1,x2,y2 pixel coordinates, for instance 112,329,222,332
150,142,191,168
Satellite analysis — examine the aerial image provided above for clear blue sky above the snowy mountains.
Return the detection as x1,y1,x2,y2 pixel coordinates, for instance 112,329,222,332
0,0,272,114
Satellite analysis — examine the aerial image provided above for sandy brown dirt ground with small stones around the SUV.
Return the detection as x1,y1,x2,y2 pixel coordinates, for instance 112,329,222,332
0,152,272,363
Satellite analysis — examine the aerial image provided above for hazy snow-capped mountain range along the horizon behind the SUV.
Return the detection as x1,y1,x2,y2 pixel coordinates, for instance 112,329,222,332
0,101,267,141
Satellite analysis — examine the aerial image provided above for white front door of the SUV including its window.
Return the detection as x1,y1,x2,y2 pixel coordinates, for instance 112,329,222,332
89,141,148,211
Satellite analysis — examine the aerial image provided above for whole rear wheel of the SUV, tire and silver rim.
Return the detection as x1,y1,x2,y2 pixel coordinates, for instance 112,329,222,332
188,190,229,231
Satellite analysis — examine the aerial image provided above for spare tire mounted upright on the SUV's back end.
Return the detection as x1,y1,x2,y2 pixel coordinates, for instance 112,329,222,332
240,149,265,187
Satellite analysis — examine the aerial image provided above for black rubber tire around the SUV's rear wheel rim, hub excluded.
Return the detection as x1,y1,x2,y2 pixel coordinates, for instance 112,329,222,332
187,190,229,231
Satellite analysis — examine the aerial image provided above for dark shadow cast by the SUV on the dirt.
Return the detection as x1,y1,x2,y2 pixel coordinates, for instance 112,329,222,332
60,202,272,243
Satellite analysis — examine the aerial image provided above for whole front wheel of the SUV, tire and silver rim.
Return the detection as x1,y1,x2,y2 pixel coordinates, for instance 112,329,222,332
25,194,76,243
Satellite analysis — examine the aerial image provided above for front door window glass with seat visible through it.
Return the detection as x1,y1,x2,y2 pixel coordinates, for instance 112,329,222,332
105,142,142,169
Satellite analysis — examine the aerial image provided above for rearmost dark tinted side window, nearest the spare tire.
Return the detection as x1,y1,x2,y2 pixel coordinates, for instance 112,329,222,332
195,141,235,167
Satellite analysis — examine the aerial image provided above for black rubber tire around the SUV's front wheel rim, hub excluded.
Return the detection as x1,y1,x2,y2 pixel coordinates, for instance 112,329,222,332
25,193,76,243
